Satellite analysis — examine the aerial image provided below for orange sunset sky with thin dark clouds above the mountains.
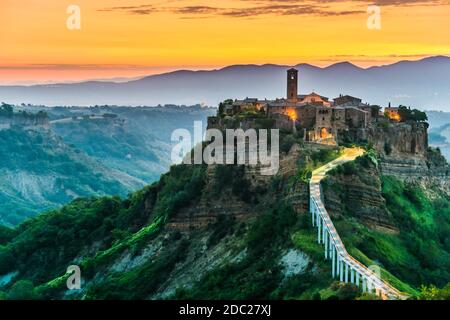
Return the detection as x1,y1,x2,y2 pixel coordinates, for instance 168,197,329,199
0,0,450,84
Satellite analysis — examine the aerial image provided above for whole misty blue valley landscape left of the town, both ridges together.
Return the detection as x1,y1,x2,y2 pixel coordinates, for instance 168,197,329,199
0,104,212,226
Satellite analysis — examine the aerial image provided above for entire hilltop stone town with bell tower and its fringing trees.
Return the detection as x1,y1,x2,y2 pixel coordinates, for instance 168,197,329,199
209,69,427,148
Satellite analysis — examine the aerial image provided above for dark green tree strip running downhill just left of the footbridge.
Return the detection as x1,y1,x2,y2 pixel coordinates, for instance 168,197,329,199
173,203,315,299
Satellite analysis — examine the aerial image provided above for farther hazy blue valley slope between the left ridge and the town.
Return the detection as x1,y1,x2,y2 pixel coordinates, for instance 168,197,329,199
46,106,215,187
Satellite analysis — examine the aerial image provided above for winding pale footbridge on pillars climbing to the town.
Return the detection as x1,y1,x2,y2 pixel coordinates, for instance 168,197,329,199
309,148,407,299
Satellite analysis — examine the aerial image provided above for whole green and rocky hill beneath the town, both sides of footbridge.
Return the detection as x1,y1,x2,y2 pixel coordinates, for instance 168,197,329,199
0,134,450,299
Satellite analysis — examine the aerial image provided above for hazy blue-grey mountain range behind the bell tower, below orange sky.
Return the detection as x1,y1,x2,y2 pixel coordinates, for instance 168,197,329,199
0,56,450,111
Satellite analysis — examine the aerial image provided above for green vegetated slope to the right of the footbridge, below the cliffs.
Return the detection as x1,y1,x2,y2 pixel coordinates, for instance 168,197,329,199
323,152,450,296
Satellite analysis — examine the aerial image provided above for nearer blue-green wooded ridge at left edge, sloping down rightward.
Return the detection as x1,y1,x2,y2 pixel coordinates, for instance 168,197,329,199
0,127,140,225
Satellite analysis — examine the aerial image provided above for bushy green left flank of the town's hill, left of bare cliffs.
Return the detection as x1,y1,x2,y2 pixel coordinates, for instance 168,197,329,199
0,166,205,297
